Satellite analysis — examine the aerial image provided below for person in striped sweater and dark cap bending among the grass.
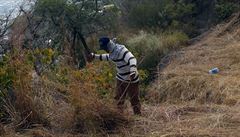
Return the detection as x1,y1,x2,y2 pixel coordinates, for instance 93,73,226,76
89,37,141,115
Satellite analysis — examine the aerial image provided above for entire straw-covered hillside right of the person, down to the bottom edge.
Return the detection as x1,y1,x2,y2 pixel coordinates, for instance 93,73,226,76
122,13,240,137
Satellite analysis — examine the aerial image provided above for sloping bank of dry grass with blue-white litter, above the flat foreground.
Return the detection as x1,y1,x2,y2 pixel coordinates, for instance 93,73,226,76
149,12,240,105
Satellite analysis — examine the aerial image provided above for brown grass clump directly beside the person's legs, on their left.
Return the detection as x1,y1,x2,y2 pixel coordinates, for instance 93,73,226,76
69,65,128,136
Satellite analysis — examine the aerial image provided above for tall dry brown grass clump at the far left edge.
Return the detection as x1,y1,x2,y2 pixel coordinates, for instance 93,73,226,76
1,51,49,129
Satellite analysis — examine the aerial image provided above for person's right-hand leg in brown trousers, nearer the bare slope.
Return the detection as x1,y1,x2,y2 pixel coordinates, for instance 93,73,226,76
128,83,141,115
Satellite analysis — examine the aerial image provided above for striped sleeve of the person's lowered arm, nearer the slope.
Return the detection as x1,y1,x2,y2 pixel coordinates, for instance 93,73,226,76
124,52,137,72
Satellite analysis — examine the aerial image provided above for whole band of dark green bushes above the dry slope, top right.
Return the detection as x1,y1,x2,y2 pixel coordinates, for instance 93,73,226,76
124,0,240,37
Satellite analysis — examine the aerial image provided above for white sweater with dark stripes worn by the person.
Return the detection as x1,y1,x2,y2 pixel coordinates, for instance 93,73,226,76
94,43,139,83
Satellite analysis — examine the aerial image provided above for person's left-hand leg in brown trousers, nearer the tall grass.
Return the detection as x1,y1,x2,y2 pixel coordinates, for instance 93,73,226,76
114,80,128,113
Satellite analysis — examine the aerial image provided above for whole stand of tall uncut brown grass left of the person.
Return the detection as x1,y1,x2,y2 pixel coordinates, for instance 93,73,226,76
0,53,128,137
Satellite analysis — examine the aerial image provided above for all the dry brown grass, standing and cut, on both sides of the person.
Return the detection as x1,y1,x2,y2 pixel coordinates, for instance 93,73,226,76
0,5,240,137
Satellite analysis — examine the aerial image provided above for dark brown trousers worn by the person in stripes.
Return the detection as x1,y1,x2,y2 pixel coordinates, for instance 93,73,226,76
115,80,141,115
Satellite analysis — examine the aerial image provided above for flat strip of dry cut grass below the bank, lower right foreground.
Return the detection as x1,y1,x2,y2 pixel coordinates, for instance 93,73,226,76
119,104,240,137
